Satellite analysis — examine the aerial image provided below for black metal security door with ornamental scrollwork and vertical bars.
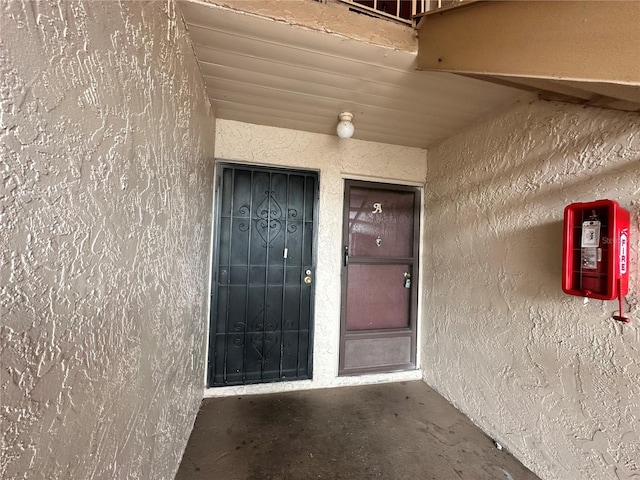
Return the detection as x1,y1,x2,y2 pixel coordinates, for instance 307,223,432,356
209,165,318,386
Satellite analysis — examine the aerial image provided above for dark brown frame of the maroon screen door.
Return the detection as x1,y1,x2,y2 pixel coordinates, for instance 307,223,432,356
338,177,423,376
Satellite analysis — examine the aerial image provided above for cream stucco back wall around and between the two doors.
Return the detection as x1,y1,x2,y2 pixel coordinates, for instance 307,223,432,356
208,120,427,395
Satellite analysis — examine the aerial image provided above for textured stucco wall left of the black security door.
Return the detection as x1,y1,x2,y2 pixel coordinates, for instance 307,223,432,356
0,0,214,479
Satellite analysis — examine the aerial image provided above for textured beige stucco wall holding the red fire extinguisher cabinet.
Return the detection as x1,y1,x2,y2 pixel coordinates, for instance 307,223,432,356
422,102,640,480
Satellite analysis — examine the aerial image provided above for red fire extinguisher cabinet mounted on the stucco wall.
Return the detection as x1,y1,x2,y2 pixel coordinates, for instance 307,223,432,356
562,200,630,300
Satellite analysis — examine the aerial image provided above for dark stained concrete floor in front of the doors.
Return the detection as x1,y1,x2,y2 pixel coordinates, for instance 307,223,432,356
176,381,538,480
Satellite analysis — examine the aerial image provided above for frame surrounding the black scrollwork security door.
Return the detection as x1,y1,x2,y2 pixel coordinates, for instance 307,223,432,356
204,163,321,389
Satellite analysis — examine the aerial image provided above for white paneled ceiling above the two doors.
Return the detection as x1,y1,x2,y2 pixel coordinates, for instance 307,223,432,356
180,0,532,148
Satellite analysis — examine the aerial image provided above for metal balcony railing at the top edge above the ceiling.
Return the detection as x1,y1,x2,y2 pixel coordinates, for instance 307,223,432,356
340,0,463,25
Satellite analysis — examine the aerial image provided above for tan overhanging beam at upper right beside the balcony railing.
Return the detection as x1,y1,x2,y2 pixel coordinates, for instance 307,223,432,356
418,0,640,110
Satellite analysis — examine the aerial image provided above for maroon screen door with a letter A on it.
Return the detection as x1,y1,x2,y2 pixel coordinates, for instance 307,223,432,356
340,180,420,375
